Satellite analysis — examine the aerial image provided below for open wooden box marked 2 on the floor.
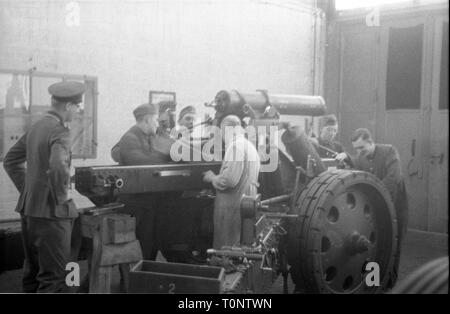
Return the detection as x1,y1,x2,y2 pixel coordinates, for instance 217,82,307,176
128,261,225,294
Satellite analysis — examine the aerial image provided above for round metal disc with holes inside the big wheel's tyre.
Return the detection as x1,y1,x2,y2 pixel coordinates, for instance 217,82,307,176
321,188,377,292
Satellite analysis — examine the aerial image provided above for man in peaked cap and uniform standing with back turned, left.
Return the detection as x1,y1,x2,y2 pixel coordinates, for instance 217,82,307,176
3,81,85,292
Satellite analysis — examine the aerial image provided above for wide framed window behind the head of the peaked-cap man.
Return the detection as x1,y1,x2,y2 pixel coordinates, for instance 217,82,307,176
0,69,97,161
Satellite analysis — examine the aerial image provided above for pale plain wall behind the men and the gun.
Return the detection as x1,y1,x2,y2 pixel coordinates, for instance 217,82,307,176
0,0,320,219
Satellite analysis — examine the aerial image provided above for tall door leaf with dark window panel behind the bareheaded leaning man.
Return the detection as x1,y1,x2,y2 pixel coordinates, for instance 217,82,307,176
377,16,430,230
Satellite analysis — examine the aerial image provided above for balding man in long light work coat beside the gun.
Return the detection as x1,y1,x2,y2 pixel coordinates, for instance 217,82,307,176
203,115,261,249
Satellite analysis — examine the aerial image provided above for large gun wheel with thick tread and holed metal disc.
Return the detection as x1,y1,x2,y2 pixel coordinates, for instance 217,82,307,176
290,170,397,293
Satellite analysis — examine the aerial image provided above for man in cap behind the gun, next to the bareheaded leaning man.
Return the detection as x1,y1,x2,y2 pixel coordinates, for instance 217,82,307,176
312,114,344,158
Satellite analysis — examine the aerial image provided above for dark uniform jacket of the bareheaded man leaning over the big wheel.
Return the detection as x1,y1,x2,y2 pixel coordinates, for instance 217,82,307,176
352,144,408,232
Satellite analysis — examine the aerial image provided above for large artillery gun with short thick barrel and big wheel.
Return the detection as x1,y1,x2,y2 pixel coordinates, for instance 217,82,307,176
75,91,397,293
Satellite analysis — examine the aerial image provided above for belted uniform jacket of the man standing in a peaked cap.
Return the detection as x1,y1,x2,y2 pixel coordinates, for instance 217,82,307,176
3,111,78,218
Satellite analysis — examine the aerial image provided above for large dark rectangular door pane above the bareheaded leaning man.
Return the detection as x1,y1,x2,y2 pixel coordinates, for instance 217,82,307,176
386,24,423,110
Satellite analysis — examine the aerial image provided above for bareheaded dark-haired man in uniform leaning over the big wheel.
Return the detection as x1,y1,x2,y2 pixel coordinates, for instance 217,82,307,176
336,129,408,288
